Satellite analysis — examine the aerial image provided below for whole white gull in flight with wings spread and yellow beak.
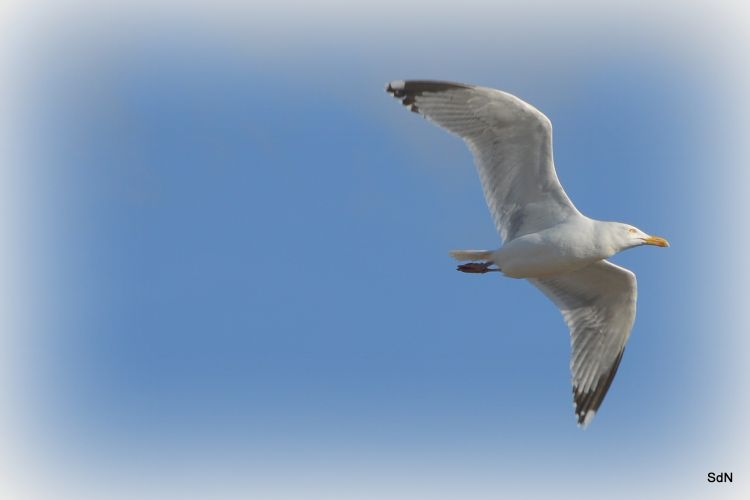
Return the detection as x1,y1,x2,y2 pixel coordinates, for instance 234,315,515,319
386,80,669,428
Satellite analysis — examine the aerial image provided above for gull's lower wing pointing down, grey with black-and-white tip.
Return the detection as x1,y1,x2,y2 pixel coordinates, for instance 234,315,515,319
529,260,638,427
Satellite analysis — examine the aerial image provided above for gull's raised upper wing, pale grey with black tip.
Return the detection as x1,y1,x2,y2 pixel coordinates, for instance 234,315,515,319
386,80,578,241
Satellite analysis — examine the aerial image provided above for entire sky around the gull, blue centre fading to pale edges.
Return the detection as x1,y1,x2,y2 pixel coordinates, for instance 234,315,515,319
3,2,748,499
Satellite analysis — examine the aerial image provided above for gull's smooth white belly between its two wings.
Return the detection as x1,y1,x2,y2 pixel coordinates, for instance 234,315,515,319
492,231,608,278
